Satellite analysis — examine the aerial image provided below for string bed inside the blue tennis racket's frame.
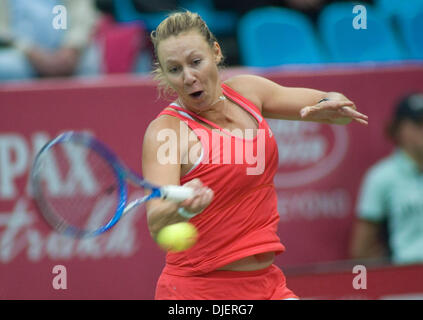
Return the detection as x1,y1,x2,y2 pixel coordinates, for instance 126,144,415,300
34,143,119,231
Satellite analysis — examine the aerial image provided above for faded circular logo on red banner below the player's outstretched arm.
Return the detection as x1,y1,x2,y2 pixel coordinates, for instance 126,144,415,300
268,120,348,188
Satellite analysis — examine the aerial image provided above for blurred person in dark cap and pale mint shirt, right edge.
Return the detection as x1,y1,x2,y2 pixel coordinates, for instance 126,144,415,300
351,93,423,264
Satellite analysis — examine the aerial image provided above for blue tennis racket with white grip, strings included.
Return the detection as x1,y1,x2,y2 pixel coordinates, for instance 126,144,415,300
30,131,194,238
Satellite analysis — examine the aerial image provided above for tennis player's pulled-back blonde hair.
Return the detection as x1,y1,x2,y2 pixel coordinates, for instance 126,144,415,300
150,11,223,96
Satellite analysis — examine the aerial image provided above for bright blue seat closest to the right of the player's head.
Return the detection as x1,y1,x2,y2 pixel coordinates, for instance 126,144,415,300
238,7,324,67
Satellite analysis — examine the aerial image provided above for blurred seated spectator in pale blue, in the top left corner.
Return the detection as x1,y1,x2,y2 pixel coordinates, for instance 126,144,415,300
0,0,101,81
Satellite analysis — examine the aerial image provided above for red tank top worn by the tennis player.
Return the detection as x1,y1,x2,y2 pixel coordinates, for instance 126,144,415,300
155,84,285,276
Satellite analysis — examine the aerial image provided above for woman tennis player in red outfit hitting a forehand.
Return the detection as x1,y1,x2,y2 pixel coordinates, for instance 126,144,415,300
142,11,367,300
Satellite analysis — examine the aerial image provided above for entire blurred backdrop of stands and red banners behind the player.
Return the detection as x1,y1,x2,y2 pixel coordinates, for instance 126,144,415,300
0,0,423,299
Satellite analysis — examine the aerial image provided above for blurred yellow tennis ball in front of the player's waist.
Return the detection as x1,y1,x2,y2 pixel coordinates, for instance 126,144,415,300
156,222,198,252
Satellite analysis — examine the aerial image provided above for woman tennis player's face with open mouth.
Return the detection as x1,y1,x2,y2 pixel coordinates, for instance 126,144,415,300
157,30,222,112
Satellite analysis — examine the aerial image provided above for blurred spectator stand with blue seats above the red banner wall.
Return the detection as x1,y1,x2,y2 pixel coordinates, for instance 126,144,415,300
0,0,423,77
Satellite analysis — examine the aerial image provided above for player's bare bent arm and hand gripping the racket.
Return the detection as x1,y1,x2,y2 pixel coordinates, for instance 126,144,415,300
142,116,213,239
